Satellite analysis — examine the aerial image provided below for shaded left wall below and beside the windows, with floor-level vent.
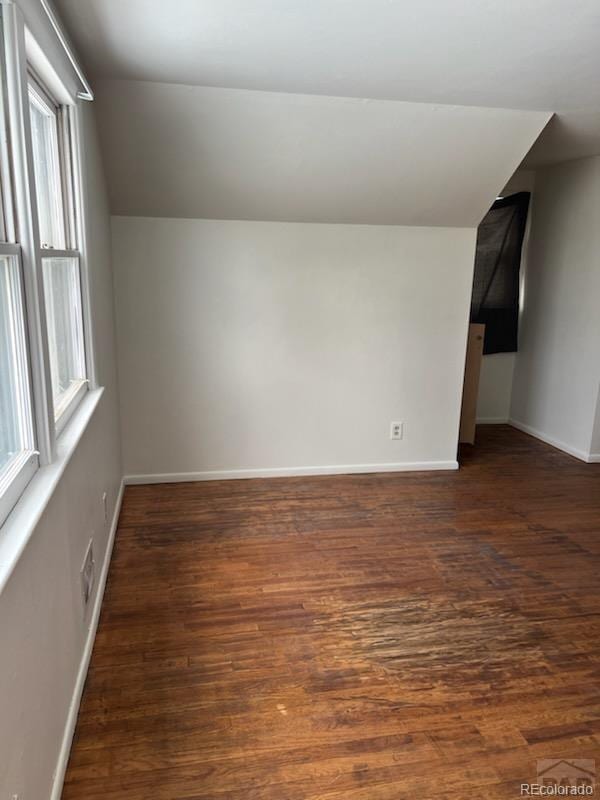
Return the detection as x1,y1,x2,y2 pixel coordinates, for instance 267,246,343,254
0,104,121,800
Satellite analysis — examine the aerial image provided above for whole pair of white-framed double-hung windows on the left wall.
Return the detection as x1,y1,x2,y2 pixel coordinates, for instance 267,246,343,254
0,3,91,535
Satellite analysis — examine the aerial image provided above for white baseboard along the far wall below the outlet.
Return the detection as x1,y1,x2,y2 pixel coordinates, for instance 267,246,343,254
123,461,458,485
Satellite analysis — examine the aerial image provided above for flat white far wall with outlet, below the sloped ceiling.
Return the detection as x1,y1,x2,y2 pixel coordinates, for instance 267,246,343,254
113,217,475,475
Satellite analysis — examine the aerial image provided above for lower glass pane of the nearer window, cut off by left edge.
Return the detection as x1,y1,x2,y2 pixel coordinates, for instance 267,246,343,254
0,256,33,475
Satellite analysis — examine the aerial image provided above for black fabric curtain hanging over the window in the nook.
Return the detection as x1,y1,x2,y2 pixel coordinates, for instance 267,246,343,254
471,192,529,353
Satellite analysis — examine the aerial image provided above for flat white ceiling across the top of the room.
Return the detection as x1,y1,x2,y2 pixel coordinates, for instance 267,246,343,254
58,0,600,164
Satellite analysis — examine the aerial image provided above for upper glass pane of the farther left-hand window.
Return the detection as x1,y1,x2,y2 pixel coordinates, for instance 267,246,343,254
29,87,65,250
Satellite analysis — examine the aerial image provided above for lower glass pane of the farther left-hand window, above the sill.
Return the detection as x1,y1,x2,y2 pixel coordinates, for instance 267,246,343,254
42,258,86,419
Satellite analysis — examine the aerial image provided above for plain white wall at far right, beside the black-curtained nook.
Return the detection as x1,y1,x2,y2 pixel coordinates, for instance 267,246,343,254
511,158,600,457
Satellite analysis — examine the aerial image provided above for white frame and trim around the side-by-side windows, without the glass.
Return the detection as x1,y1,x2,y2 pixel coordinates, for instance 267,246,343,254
0,3,95,541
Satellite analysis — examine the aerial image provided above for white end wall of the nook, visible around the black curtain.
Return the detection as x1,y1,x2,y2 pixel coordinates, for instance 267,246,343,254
477,169,535,424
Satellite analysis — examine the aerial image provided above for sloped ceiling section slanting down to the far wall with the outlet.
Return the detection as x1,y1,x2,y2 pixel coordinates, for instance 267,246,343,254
97,81,549,227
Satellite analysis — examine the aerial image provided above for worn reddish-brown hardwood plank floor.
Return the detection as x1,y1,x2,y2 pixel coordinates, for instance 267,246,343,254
63,426,600,800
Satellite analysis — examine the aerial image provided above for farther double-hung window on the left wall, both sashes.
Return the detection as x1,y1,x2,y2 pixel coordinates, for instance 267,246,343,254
29,75,87,430
